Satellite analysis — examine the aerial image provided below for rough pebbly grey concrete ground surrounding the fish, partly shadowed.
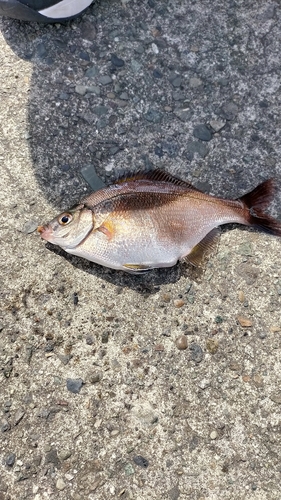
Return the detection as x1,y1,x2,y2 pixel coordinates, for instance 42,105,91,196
0,0,281,500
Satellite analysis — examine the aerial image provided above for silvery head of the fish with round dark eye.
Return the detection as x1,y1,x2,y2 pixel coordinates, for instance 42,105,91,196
37,205,94,250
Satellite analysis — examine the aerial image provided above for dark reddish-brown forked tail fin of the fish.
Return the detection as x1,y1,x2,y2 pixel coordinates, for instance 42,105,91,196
239,179,281,236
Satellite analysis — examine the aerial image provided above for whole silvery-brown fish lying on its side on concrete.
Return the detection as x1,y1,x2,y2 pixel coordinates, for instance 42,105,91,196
37,169,281,274
